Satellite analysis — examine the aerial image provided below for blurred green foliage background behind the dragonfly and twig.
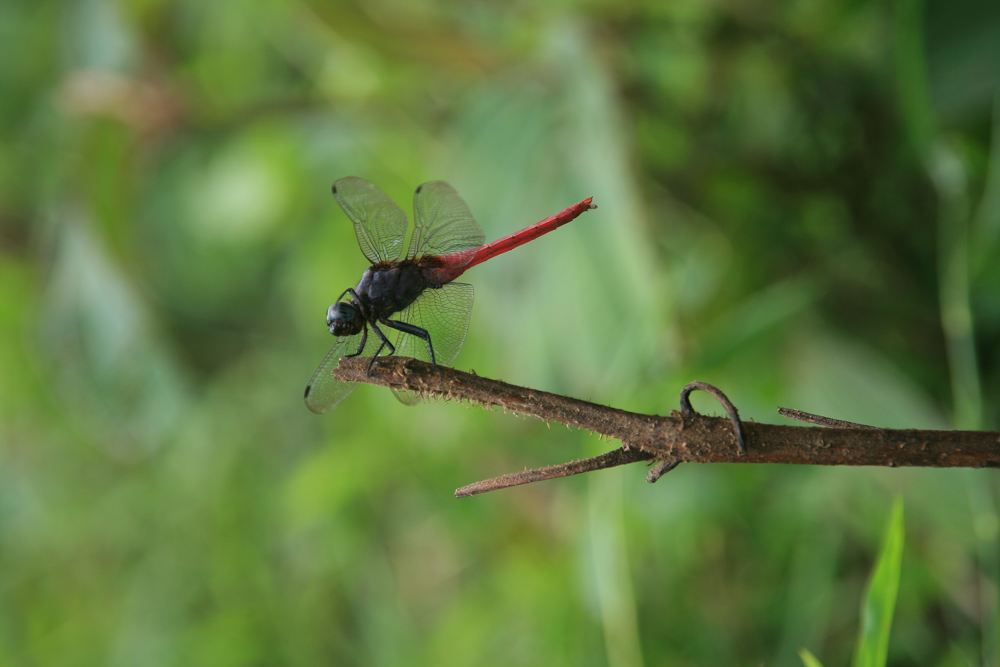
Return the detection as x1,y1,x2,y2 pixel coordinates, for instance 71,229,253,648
0,0,1000,667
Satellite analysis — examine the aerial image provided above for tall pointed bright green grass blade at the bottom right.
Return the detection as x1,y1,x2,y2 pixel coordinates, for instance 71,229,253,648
854,498,903,667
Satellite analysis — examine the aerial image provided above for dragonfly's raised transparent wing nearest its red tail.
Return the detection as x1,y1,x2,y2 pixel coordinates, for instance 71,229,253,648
406,181,485,257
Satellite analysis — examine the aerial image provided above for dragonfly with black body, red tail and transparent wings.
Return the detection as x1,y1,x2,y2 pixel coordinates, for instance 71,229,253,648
305,176,597,413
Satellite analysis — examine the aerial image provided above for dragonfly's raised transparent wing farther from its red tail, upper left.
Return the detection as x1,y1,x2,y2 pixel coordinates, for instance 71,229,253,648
333,176,407,264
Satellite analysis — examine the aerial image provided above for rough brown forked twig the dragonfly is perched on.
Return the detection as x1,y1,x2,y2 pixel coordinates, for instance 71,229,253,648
334,357,1000,494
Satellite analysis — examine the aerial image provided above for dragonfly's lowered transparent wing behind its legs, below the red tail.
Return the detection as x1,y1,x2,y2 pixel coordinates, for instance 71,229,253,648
393,283,474,405
